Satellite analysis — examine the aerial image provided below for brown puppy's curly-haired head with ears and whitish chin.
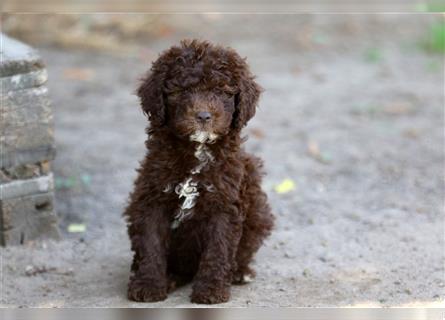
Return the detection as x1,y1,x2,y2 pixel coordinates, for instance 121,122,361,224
137,40,261,142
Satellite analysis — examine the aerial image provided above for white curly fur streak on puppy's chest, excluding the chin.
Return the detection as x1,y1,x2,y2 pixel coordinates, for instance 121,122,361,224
163,143,216,229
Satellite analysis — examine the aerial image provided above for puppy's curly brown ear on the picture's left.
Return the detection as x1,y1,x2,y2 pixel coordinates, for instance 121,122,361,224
136,68,166,127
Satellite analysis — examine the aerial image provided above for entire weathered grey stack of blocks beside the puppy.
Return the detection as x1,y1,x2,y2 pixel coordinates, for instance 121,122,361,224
0,34,60,246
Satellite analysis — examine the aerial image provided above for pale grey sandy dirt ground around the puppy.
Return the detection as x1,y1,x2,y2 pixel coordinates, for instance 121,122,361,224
0,15,445,307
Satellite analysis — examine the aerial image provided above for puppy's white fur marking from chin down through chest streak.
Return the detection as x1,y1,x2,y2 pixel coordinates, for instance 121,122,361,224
163,131,218,229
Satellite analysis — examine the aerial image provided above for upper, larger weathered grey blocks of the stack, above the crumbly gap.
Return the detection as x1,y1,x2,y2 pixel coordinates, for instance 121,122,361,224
0,35,55,169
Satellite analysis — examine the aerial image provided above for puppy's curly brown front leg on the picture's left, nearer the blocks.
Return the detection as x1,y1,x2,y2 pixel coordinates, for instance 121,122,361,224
128,207,170,302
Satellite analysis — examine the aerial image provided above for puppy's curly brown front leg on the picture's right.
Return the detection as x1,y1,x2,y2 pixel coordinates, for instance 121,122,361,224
191,212,242,304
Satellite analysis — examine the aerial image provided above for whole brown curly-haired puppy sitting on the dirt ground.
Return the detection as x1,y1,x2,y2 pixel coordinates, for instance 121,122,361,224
125,40,273,303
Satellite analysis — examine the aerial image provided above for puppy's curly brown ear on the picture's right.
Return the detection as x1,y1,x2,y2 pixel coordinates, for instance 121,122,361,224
233,66,263,130
